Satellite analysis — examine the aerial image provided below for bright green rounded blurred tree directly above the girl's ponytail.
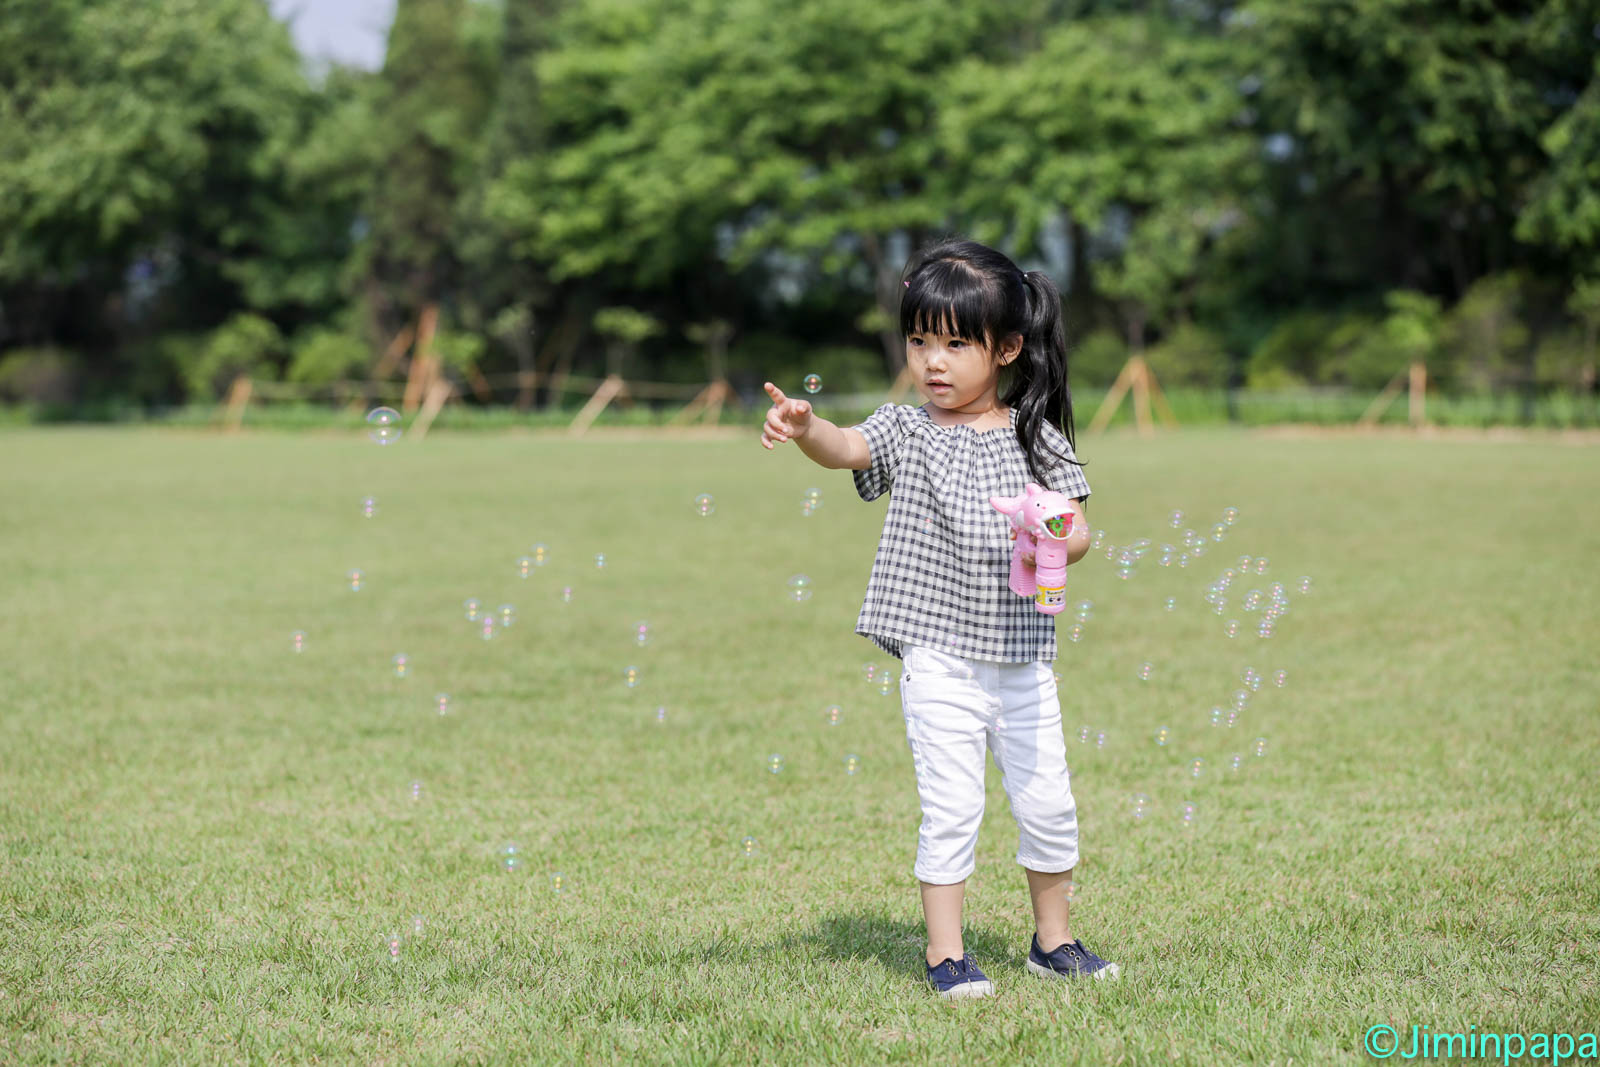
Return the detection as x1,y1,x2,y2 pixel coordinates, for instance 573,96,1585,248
938,14,1253,352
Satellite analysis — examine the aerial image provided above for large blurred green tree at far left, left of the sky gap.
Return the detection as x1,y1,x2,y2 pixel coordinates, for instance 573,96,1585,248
0,0,329,396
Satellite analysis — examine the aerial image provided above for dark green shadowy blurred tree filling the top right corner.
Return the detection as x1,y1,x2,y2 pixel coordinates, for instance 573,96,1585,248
1238,0,1597,302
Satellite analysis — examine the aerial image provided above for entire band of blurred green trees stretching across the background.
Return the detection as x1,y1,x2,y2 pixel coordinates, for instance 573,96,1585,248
0,0,1600,412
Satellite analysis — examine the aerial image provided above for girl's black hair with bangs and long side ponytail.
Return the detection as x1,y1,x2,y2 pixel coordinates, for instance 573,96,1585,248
901,238,1083,485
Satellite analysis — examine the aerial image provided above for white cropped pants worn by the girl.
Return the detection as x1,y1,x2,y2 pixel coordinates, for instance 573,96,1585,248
901,645,1078,885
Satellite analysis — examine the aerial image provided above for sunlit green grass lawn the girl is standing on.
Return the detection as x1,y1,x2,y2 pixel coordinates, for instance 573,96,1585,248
0,429,1600,1064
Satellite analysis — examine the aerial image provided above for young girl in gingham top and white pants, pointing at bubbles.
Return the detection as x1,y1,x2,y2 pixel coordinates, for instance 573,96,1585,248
762,242,1120,997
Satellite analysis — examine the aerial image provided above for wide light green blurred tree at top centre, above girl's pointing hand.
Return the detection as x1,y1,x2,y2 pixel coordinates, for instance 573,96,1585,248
504,0,1049,375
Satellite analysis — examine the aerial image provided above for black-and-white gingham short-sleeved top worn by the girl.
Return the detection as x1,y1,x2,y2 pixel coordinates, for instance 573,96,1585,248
851,403,1090,662
